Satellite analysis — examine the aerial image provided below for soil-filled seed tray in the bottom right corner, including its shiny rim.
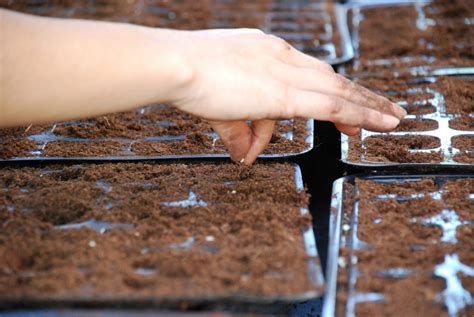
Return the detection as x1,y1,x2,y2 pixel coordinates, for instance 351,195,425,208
323,175,474,317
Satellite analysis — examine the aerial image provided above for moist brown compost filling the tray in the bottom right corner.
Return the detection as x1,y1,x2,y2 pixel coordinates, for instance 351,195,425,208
336,177,474,316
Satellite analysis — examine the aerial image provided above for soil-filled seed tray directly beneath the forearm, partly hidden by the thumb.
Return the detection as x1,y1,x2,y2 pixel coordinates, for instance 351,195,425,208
0,105,313,161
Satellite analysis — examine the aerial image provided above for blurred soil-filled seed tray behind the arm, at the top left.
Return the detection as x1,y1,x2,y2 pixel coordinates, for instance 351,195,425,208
0,0,353,64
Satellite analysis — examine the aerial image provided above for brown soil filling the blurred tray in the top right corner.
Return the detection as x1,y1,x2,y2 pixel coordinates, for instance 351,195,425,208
346,0,474,73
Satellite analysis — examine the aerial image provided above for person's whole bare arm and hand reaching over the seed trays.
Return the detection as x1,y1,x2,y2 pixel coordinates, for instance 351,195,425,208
0,9,406,164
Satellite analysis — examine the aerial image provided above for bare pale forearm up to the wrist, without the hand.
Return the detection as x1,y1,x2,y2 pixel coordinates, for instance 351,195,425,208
0,10,191,127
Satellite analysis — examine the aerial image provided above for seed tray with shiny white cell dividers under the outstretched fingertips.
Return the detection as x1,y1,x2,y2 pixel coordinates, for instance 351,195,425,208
341,76,474,169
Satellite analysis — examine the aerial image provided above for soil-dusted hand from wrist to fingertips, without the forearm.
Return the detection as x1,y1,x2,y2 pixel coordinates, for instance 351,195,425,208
168,29,406,164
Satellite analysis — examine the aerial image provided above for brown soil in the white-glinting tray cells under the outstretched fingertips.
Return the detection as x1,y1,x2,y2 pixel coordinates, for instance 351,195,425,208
348,77,474,164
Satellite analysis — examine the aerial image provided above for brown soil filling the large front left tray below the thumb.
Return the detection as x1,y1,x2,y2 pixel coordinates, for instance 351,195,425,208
0,163,315,301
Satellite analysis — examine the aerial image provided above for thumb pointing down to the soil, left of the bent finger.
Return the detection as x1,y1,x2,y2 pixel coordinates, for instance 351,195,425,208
210,121,252,162
